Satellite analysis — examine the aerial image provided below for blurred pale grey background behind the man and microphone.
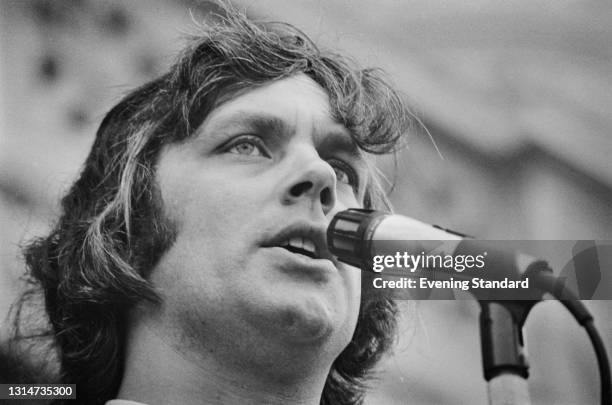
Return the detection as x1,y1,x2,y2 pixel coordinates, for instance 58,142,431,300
0,0,612,405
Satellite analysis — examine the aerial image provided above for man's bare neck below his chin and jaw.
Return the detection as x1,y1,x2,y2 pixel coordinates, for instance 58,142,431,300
118,310,329,405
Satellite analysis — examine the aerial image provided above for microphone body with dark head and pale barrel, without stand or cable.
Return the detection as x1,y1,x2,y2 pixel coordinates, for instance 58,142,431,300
327,209,550,299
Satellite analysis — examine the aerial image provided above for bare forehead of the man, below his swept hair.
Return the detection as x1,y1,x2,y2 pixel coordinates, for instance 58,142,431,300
202,74,353,144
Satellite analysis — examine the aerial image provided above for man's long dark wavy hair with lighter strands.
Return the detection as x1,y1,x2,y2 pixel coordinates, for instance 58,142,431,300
13,6,410,404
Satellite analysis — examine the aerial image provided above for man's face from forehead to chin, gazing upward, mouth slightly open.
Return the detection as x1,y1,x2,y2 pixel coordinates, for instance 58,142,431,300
152,75,367,366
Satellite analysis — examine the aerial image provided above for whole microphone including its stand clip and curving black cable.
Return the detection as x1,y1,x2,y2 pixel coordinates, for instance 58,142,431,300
327,209,612,404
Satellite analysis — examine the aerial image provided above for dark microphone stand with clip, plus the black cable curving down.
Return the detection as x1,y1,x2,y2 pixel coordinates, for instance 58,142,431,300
471,256,612,405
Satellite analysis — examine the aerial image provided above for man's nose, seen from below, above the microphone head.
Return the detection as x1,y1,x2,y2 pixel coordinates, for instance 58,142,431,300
283,154,337,215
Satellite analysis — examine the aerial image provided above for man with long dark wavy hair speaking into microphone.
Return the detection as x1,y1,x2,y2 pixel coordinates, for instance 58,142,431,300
11,3,408,405
